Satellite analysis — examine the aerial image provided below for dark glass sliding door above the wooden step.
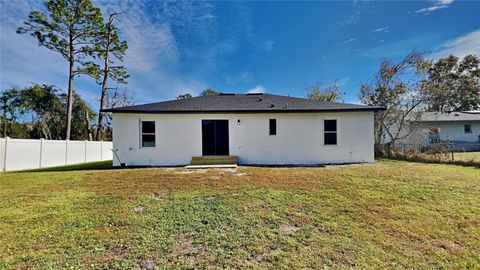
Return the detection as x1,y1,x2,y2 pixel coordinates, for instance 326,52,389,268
202,120,228,156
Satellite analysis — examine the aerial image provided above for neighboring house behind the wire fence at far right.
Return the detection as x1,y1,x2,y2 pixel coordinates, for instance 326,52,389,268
415,112,480,150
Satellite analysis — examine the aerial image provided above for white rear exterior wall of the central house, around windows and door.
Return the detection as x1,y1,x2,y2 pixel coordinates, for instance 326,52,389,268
113,112,374,166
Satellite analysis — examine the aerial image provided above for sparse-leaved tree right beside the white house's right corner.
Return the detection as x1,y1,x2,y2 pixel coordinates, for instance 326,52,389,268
360,52,426,152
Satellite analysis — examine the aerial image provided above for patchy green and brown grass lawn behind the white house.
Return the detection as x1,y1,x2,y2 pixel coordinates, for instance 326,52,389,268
0,160,480,269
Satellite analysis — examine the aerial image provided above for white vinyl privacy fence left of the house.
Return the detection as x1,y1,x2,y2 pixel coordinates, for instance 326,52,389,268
0,138,112,171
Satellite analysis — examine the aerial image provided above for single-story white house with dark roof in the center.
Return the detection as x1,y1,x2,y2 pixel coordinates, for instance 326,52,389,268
105,94,383,166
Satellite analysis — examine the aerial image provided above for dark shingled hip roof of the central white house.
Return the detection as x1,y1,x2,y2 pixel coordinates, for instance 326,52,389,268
103,94,384,113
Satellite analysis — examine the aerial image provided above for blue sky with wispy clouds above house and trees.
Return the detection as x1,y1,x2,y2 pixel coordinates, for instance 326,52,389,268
0,0,480,107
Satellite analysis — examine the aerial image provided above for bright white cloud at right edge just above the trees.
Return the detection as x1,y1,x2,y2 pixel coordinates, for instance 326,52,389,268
432,29,480,59
